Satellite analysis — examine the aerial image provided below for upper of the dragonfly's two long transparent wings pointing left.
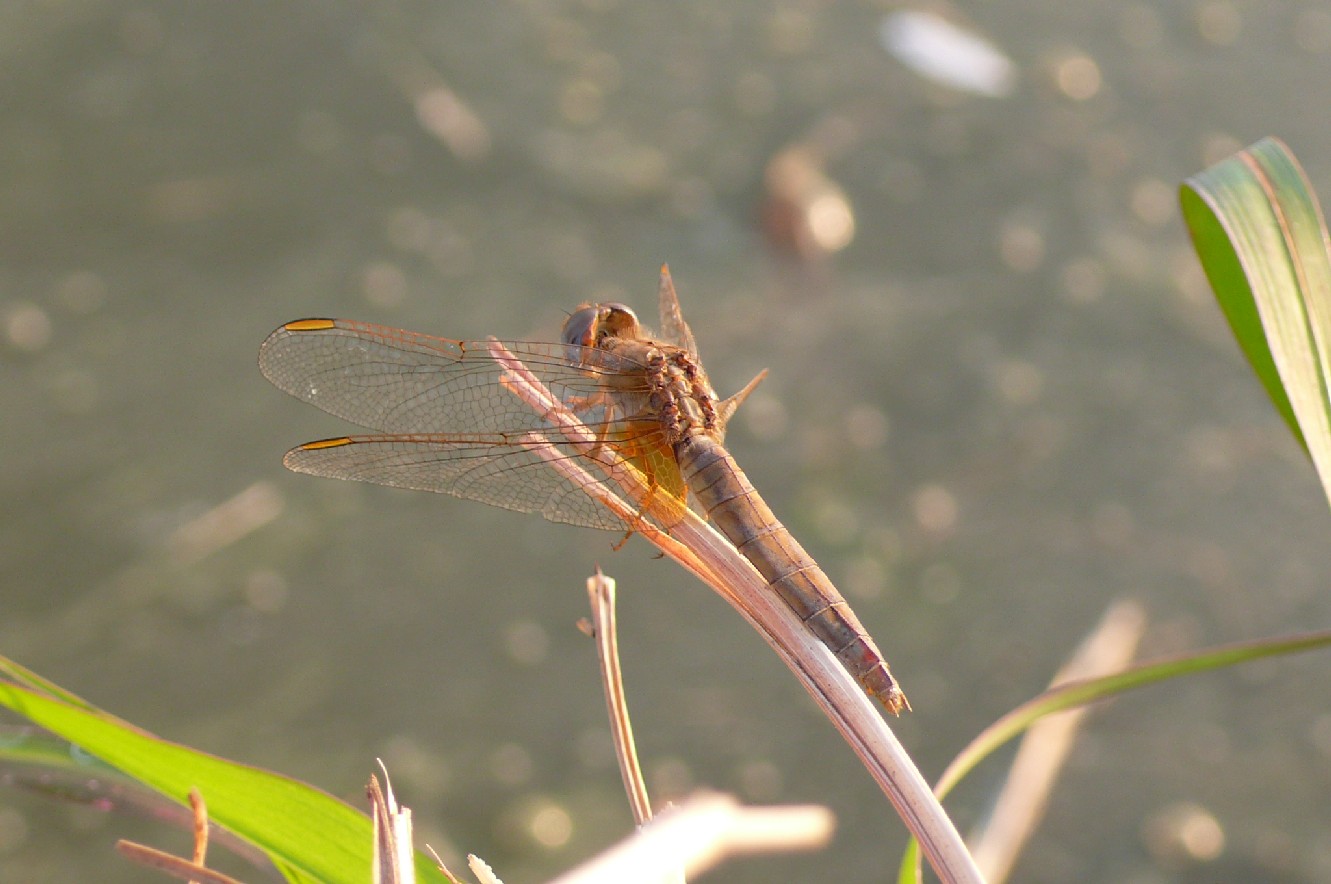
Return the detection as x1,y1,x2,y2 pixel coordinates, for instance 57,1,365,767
258,320,644,434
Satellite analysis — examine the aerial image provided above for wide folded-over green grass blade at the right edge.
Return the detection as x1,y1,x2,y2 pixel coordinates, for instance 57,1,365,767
1179,138,1331,498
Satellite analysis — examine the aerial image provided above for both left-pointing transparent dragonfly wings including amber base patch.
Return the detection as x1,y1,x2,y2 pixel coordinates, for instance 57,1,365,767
260,320,684,531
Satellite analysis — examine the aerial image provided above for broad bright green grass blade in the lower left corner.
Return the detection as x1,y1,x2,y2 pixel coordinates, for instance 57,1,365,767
0,662,446,884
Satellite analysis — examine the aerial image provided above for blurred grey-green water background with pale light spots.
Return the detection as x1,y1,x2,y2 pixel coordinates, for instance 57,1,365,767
0,0,1331,884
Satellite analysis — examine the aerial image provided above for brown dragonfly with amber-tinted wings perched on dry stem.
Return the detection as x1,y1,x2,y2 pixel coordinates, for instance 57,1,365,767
258,266,909,714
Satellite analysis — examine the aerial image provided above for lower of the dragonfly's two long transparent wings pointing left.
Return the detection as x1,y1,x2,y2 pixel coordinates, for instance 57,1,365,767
282,435,628,531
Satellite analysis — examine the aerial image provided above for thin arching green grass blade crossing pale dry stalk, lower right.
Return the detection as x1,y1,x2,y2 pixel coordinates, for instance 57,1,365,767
897,630,1331,884
